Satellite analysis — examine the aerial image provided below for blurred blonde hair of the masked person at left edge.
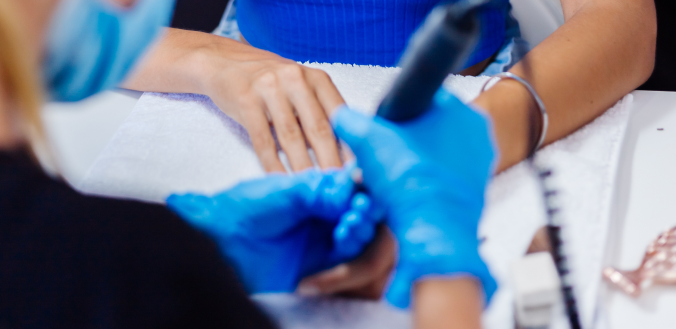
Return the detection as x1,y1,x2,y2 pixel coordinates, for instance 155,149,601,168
0,0,44,152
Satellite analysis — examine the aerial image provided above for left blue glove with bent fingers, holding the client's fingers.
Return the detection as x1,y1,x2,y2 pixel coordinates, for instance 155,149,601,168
167,171,377,293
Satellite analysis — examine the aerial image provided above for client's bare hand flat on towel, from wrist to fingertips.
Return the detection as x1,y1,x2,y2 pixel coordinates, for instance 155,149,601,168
204,41,345,172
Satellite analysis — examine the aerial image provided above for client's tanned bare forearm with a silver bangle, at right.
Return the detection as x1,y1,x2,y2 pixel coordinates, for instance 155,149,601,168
475,0,657,171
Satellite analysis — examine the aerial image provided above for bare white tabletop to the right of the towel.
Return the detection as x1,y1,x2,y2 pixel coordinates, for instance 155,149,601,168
605,91,676,329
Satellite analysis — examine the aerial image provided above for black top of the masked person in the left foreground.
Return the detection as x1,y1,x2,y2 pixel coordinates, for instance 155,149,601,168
0,152,273,329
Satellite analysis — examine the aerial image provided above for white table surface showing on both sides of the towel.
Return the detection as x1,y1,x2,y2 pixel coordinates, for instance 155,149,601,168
46,91,676,329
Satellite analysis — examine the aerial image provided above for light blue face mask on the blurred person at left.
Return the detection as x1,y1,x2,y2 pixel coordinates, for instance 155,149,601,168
43,0,174,102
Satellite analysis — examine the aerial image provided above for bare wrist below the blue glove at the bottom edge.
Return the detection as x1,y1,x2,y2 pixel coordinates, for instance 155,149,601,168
414,279,483,329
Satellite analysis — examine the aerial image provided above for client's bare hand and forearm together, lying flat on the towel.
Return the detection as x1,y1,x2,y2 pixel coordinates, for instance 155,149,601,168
124,29,345,172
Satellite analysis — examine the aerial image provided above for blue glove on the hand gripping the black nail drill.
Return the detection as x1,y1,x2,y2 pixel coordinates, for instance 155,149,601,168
331,90,497,308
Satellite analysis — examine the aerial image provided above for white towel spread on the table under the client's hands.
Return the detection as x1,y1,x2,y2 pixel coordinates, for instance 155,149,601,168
80,64,632,329
